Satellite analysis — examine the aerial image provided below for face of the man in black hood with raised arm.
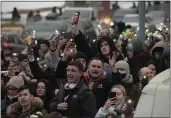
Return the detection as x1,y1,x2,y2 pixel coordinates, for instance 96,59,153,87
100,41,110,55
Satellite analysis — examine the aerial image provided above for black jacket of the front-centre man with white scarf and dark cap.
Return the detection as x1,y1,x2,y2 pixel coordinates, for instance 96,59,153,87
50,80,97,118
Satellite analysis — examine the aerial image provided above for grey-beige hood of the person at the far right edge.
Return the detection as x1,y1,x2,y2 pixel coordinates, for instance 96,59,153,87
151,41,167,55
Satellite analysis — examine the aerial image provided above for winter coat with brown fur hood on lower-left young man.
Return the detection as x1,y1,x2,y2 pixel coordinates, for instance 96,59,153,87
7,97,48,118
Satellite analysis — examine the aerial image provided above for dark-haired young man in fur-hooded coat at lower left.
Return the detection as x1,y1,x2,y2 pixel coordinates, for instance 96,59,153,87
7,86,48,118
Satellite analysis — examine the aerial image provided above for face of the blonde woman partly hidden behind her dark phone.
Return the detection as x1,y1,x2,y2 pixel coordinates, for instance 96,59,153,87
111,88,125,105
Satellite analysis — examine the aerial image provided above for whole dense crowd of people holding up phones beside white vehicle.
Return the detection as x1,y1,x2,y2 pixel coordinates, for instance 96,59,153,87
1,13,170,118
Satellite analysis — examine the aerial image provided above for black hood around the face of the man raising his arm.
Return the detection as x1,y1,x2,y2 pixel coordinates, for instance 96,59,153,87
97,36,116,55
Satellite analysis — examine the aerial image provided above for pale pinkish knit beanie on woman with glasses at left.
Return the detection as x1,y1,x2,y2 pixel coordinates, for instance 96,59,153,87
6,76,24,89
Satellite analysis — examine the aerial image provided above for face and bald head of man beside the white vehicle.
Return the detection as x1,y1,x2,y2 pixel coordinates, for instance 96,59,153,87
140,67,154,81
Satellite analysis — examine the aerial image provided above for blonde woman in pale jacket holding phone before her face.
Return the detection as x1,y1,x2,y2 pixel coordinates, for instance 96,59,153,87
95,85,133,118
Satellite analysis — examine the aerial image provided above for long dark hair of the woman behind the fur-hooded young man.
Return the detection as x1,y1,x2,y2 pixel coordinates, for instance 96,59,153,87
36,79,53,98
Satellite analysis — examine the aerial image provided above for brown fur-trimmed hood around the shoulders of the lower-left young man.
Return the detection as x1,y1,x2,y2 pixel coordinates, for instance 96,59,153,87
7,97,43,115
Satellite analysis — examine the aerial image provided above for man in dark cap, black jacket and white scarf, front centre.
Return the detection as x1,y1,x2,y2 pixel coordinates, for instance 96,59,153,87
51,60,97,118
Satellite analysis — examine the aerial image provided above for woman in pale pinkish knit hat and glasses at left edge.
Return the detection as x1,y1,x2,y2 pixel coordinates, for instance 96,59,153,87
1,76,24,114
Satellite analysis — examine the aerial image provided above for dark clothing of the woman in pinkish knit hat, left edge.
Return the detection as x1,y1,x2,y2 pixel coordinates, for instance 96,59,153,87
1,96,18,115
